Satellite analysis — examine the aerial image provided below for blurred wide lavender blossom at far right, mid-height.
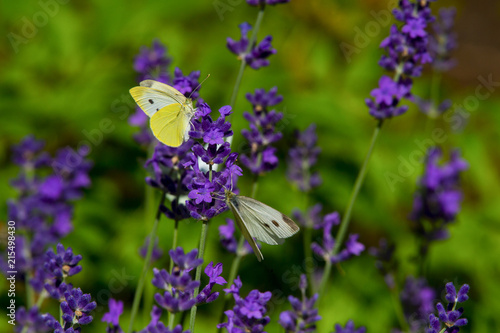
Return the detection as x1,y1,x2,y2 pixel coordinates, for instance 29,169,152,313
410,147,468,246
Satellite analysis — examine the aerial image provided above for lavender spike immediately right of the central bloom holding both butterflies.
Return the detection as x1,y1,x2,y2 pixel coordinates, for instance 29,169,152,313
240,87,283,175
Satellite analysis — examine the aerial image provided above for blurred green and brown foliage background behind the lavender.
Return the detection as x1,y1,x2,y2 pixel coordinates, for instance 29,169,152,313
0,0,500,332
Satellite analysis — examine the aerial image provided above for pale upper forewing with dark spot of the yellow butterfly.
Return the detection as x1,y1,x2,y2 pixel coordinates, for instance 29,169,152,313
130,80,187,117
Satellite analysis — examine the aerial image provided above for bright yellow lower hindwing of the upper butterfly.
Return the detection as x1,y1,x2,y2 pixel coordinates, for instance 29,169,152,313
150,103,191,147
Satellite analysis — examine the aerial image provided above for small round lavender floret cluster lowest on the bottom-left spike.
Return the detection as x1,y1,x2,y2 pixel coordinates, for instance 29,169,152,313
61,288,97,325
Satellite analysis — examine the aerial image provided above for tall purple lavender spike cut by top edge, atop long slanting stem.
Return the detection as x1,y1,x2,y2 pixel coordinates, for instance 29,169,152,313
366,0,434,120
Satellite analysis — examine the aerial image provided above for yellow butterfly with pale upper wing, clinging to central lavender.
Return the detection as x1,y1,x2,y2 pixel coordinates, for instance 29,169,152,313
130,80,195,147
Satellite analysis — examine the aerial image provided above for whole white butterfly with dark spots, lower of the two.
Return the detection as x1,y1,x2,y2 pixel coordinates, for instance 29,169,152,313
225,190,299,261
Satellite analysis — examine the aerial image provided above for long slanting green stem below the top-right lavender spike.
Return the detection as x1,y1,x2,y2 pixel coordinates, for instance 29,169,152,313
319,119,384,297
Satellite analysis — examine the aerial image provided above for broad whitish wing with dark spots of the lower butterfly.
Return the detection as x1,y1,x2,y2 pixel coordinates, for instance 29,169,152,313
236,196,299,245
